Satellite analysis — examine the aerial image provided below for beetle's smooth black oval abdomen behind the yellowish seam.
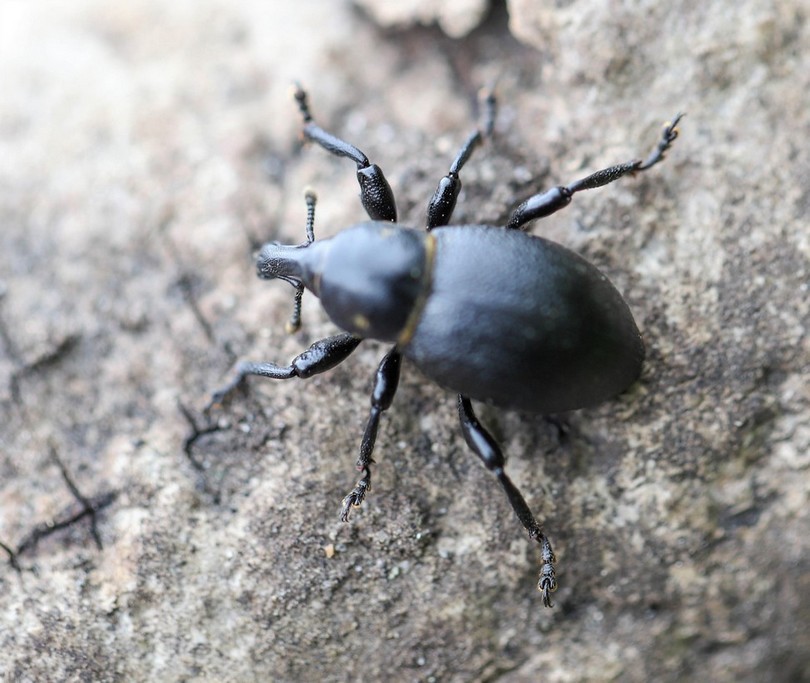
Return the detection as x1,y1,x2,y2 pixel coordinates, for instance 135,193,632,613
402,226,644,413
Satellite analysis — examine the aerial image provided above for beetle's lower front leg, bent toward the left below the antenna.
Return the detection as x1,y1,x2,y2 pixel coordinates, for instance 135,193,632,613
205,332,362,412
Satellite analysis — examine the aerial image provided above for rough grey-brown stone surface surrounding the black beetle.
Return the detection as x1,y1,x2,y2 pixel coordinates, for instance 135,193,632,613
0,0,810,682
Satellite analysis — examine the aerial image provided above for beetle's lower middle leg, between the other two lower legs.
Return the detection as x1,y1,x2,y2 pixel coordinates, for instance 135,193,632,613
340,346,402,522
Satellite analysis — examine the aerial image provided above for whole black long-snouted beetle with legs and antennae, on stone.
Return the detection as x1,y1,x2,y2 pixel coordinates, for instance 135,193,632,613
209,87,681,607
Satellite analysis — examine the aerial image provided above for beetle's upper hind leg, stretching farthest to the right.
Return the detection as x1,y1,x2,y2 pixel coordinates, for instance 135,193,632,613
506,114,683,229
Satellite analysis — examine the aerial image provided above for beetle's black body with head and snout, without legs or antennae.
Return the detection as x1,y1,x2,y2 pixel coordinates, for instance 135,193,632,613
278,221,644,413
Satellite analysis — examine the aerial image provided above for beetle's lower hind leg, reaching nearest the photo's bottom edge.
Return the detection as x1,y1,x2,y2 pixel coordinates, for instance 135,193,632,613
458,394,557,607
